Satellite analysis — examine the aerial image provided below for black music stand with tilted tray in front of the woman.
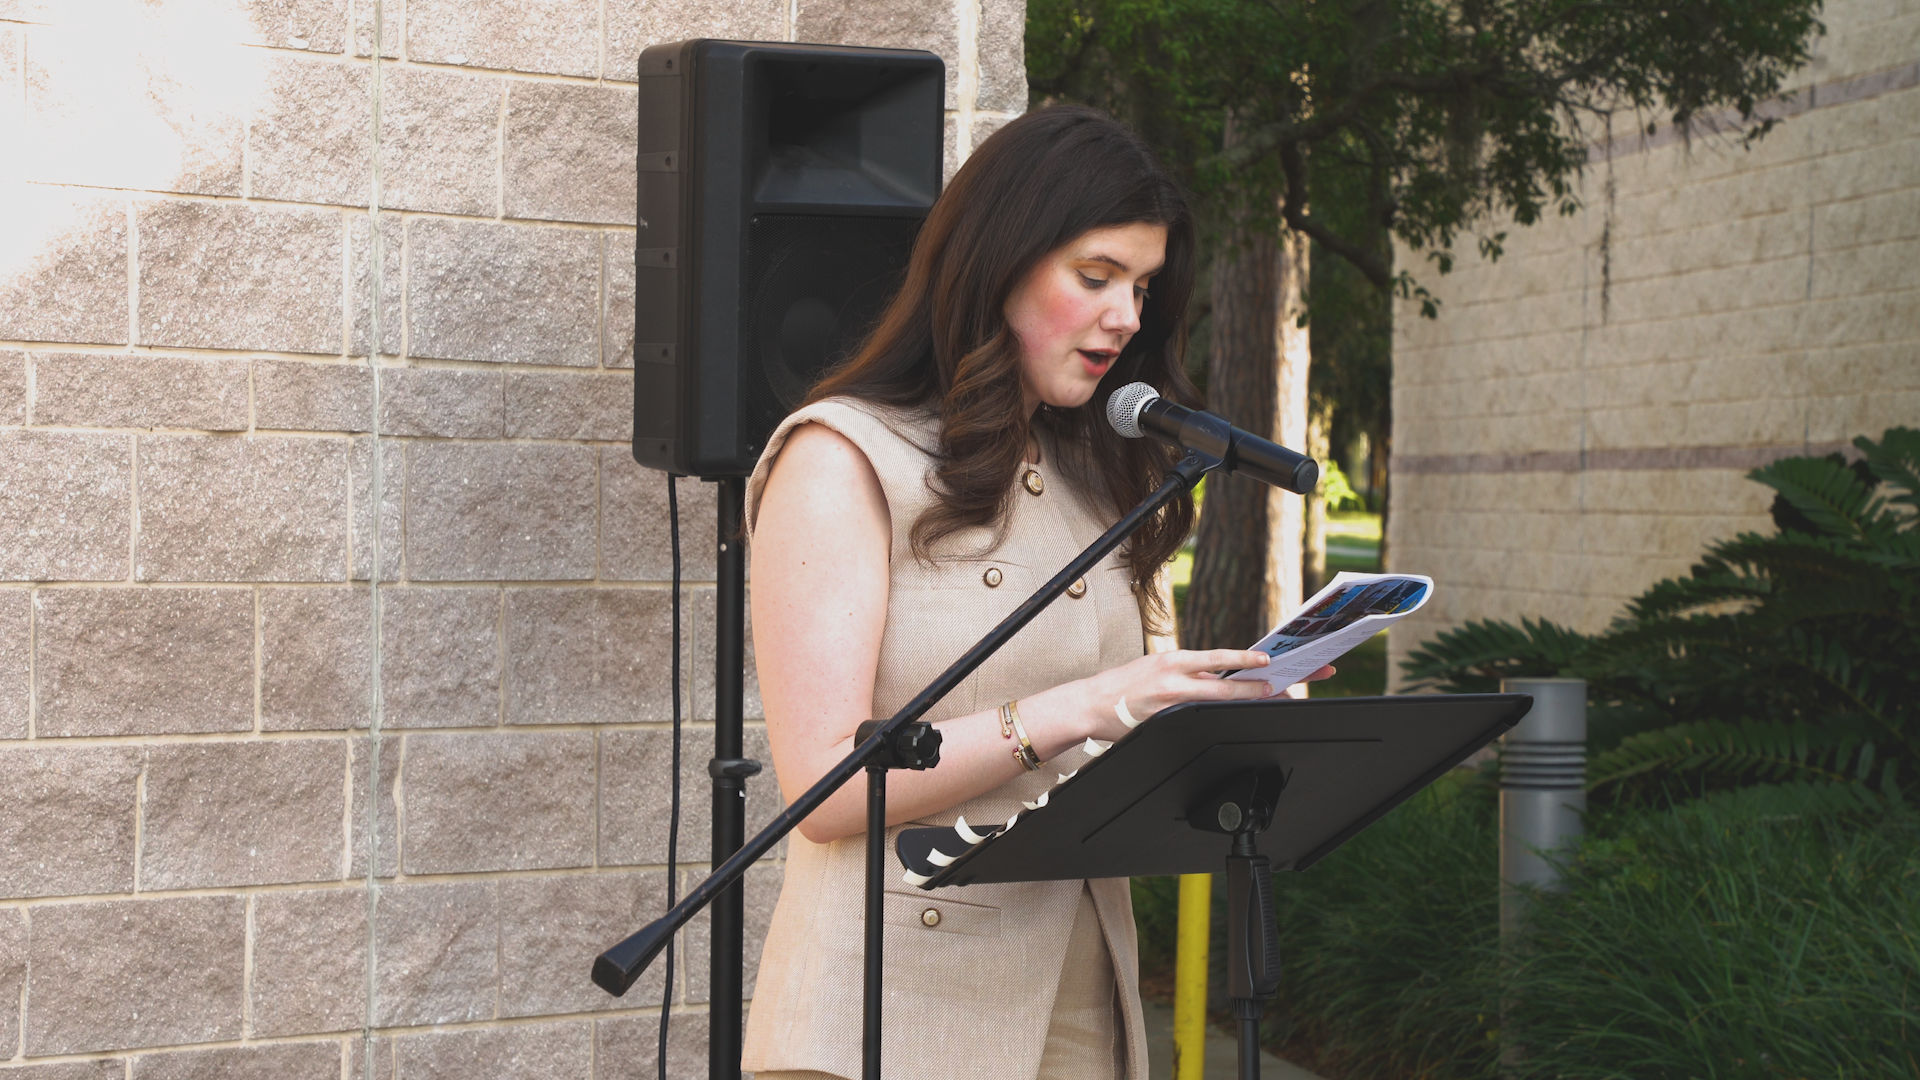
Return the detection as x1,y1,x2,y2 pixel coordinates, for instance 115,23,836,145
897,694,1532,1080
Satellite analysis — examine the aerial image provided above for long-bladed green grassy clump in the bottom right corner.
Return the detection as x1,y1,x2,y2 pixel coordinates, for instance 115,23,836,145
1505,799,1920,1080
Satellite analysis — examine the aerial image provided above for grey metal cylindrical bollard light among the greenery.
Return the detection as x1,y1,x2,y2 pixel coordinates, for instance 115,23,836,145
1500,678,1586,932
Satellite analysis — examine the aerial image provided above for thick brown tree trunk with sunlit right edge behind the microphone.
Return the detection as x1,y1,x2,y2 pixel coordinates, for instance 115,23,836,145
1181,219,1308,650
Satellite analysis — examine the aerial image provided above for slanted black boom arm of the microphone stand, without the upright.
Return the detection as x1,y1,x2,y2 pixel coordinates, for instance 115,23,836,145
593,450,1219,997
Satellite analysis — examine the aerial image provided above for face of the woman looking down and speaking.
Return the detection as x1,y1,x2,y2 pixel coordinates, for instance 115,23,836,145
1006,223,1167,413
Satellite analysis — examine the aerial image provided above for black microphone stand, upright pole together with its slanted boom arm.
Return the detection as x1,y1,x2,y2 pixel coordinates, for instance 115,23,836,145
593,440,1223,1080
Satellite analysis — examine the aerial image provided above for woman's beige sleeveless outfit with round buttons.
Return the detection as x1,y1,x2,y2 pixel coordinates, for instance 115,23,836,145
741,400,1146,1080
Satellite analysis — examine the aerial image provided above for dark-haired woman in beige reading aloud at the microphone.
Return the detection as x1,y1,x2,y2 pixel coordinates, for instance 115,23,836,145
743,108,1328,1080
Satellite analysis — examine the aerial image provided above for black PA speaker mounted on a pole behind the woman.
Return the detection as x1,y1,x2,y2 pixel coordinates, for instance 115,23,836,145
634,38,947,477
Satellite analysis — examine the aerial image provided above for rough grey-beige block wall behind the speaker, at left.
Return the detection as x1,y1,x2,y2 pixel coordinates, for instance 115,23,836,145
0,0,1025,1080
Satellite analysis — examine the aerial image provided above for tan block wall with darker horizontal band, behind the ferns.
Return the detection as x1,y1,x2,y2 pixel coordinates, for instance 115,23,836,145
1388,0,1920,676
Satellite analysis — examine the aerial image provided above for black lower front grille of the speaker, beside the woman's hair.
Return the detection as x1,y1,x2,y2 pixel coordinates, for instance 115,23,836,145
741,213,920,440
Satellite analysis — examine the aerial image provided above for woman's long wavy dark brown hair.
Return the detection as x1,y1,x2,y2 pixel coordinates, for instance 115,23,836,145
808,106,1198,615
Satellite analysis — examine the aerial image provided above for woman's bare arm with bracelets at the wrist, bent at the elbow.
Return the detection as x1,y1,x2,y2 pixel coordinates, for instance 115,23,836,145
751,425,1331,844
